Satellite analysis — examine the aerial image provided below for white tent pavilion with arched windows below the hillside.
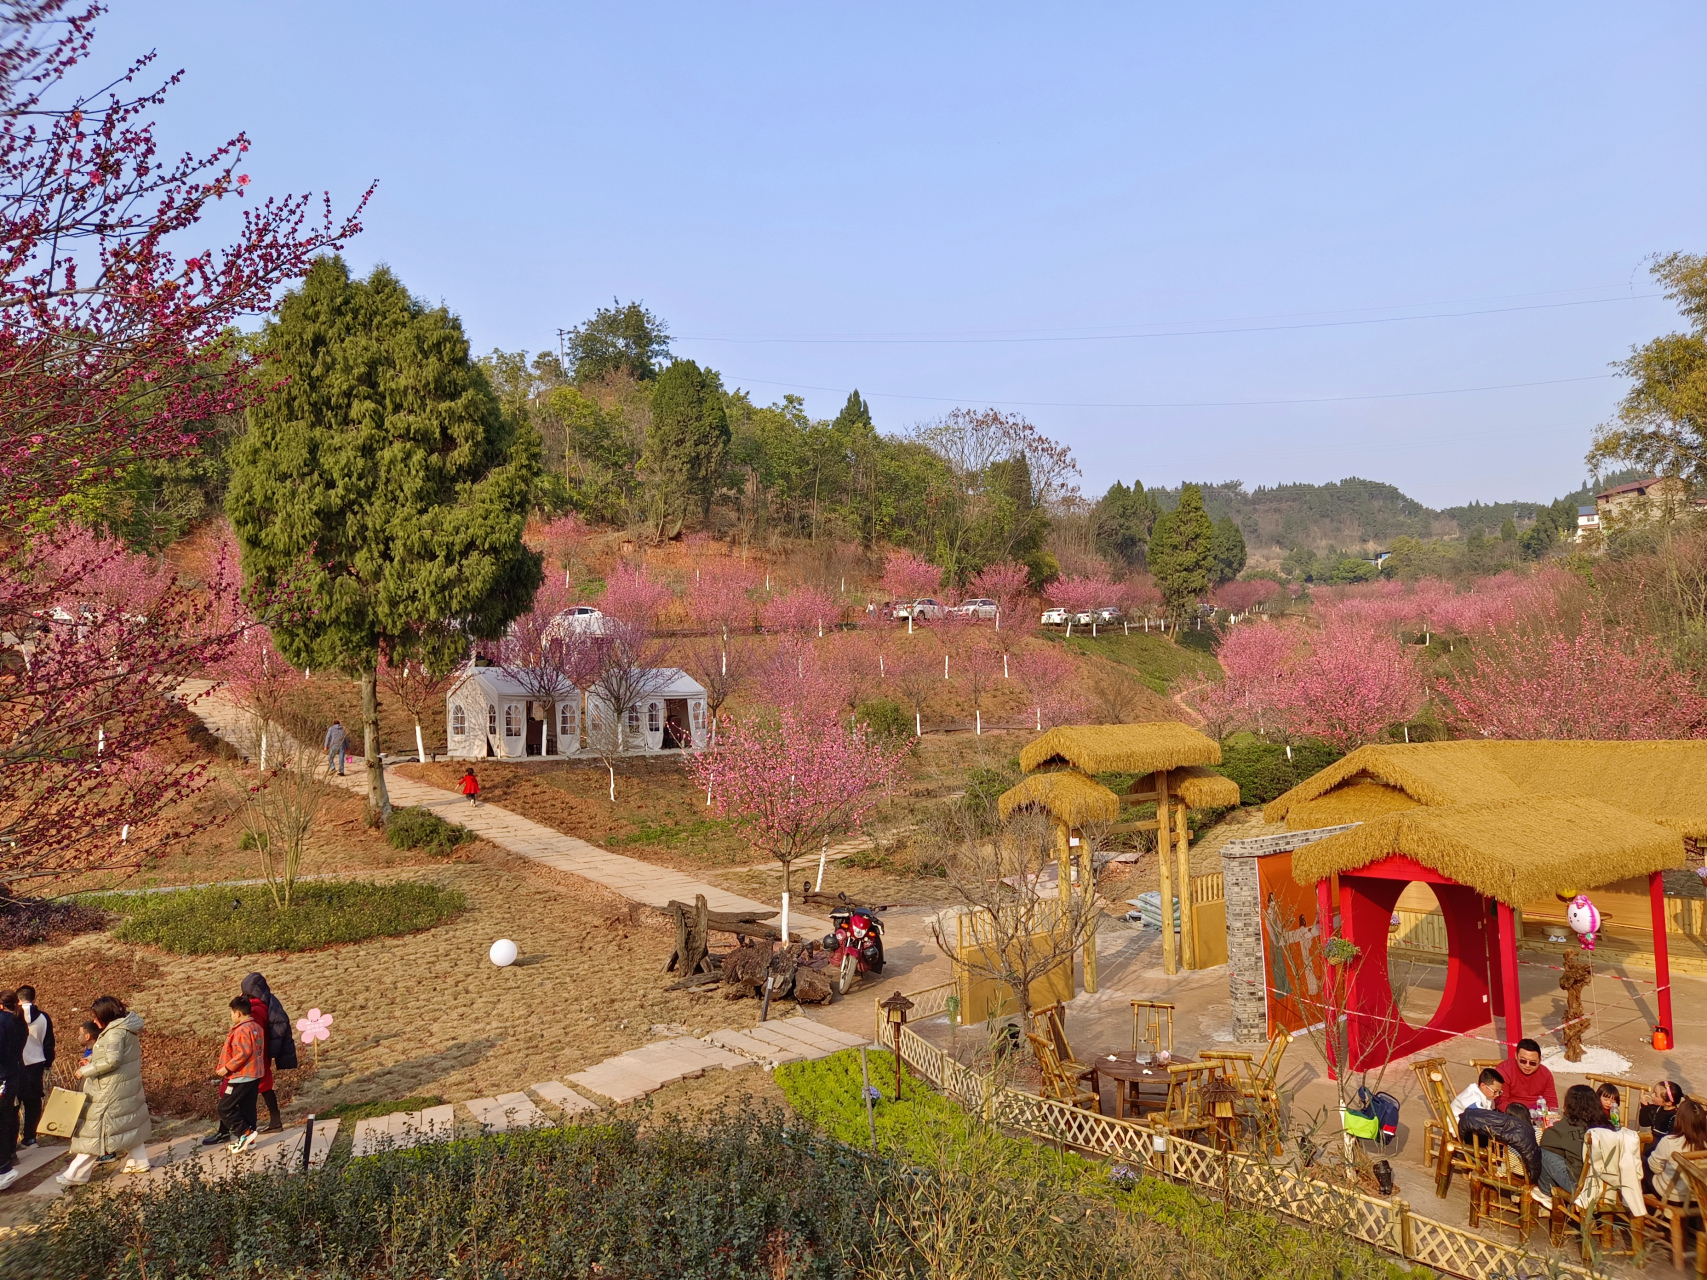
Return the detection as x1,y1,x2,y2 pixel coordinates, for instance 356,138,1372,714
446,667,708,759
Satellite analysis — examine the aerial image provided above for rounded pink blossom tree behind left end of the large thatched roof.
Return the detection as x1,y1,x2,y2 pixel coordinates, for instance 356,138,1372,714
1283,620,1424,751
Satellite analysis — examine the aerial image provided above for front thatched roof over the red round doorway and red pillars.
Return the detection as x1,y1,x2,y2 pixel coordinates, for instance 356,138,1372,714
1292,795,1685,906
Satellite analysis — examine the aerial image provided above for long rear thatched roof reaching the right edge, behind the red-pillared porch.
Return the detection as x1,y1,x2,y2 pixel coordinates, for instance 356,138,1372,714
1265,741,1707,843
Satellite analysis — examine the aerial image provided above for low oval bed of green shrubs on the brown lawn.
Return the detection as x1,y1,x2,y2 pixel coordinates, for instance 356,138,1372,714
80,881,468,956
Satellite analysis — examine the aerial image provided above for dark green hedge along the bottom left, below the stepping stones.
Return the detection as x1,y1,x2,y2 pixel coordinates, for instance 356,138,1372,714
0,1111,872,1280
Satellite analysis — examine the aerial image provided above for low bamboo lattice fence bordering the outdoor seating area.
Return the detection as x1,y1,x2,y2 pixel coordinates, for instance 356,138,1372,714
876,983,1593,1280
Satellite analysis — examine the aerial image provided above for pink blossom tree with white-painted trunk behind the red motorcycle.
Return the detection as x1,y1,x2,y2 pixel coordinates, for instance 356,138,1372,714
685,707,913,939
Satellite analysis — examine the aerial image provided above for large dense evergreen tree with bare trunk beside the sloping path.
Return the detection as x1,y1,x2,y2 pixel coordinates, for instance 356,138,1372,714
225,258,541,817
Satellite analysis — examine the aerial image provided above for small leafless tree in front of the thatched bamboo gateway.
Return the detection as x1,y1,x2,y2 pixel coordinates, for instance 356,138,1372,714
927,800,1098,1026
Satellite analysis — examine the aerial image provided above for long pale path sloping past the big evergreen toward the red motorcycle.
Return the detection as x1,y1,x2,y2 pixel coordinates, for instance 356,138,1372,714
179,679,830,939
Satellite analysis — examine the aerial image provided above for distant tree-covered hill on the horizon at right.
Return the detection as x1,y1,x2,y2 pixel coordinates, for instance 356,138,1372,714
1152,471,1646,558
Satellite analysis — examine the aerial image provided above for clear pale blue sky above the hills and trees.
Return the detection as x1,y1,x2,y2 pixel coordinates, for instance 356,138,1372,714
99,0,1707,505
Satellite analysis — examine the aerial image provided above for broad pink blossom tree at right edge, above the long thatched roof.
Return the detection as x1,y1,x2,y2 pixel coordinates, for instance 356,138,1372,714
1436,618,1707,741
